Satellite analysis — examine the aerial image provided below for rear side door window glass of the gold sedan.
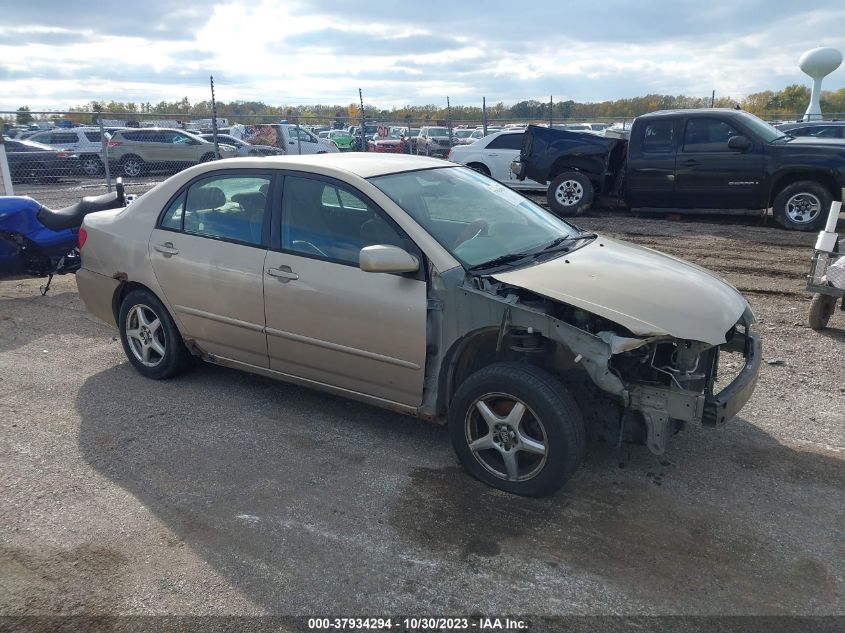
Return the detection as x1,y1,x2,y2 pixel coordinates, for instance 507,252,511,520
161,175,270,246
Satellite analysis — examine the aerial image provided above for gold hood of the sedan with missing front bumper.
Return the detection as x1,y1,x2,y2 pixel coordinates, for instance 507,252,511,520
493,237,748,345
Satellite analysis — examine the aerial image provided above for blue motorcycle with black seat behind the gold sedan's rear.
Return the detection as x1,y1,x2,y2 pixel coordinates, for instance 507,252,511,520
0,179,127,295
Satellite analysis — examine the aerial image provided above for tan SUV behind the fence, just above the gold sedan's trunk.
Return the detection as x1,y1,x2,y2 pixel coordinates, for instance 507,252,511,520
108,128,238,178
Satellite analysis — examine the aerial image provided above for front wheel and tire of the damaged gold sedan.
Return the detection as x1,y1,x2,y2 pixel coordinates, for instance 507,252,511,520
449,363,586,497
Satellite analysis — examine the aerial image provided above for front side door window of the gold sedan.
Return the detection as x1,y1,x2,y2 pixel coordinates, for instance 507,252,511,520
282,176,409,266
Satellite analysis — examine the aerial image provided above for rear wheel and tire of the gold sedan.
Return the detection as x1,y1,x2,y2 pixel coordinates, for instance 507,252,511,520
118,288,190,380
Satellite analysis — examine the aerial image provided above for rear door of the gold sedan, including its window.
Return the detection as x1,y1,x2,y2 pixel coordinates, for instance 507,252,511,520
149,170,273,368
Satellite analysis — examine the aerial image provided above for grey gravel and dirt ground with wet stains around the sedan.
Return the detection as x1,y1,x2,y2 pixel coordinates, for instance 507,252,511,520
0,205,845,615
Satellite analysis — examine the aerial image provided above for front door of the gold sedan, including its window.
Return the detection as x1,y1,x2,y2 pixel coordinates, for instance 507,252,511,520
264,175,427,406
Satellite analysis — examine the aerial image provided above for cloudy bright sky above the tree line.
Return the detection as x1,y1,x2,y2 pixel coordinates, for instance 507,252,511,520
0,0,845,110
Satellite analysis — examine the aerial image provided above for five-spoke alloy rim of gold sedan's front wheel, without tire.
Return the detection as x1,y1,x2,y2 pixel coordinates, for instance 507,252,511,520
464,393,548,481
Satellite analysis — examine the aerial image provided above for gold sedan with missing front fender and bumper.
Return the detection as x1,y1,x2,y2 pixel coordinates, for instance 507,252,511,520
77,153,761,496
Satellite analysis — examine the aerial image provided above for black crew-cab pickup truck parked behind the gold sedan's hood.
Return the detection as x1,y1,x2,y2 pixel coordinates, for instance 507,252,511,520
511,109,845,231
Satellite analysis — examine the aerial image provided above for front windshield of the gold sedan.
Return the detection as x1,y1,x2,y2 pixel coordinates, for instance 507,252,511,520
370,167,581,268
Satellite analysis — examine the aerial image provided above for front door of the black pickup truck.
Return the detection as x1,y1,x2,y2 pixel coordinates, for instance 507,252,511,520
674,117,765,209
